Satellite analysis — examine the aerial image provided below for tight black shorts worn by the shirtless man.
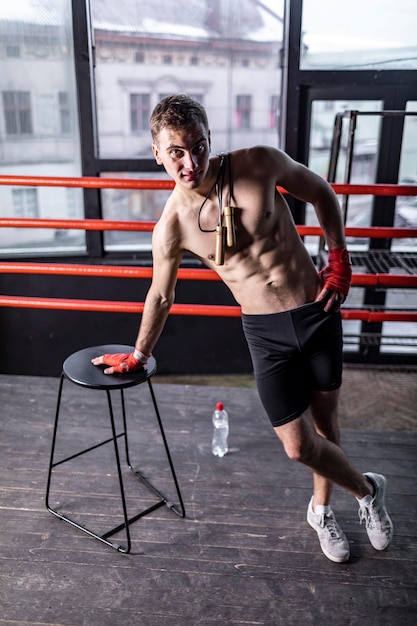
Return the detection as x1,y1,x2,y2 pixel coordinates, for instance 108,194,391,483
242,302,343,426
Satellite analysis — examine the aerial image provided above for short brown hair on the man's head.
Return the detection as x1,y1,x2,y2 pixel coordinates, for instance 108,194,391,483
150,94,209,141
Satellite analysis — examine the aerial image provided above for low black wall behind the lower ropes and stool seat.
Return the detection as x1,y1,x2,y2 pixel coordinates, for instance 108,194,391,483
0,274,252,376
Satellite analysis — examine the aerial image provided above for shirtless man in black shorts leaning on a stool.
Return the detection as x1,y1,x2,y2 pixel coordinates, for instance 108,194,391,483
93,95,393,562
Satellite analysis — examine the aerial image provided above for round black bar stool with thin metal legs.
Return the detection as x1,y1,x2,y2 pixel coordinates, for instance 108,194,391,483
46,345,185,554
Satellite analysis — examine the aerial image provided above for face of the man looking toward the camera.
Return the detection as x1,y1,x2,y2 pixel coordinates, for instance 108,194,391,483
152,123,210,190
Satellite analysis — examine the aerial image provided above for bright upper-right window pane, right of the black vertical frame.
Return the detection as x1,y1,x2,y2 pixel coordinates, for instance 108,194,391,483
300,0,417,70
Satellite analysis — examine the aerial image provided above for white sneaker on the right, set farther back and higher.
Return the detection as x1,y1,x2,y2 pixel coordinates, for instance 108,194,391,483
357,472,394,550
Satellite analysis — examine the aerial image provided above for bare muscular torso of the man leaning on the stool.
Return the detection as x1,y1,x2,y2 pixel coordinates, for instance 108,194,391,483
162,149,321,314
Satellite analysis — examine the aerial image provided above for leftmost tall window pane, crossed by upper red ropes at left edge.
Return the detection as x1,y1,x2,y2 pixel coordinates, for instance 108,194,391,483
0,0,85,255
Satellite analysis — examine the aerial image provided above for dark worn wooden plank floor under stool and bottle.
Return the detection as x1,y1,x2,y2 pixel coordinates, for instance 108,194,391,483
0,373,417,626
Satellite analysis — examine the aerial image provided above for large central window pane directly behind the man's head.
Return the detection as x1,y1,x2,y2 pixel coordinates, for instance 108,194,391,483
91,0,283,158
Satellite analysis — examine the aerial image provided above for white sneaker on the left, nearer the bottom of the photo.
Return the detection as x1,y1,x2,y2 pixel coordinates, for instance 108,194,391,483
307,496,350,563
